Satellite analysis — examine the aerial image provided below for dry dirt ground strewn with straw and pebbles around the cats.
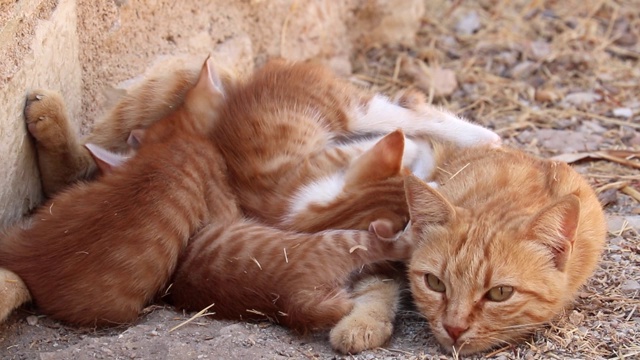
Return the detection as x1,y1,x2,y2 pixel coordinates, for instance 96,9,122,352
0,0,640,360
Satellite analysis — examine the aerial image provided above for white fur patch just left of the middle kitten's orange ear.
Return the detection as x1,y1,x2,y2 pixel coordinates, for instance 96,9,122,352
288,173,344,219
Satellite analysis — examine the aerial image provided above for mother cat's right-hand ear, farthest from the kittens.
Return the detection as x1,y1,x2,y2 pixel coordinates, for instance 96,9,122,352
528,194,580,271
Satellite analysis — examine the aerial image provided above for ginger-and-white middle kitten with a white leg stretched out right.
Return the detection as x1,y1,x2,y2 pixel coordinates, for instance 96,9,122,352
214,61,500,232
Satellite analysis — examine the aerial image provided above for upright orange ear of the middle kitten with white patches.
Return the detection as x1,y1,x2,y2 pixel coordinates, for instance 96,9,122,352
345,130,404,188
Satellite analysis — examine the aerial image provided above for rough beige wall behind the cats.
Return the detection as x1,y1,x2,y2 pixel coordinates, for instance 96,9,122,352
0,0,424,229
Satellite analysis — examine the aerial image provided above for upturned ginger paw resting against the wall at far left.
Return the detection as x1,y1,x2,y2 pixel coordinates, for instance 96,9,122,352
24,89,70,147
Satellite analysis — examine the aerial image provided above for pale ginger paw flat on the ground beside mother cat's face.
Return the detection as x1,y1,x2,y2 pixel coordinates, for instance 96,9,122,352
329,314,393,354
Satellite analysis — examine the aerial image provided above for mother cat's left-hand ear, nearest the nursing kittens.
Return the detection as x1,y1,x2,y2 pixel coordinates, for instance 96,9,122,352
404,174,456,224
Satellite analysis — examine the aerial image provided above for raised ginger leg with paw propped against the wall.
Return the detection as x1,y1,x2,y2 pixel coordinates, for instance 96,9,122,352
24,90,96,197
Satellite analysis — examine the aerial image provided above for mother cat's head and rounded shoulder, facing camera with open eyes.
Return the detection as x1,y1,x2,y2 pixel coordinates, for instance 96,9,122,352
405,139,606,354
